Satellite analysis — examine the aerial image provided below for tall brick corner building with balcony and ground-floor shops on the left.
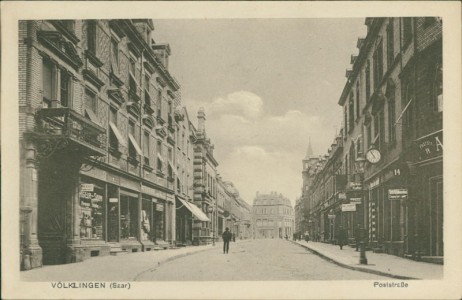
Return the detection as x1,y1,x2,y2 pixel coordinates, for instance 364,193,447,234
19,19,184,269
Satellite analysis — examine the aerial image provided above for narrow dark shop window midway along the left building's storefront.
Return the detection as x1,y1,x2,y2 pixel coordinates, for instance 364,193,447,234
120,195,138,239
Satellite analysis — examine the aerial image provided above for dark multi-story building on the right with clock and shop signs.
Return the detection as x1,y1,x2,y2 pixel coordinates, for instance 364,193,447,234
302,17,443,258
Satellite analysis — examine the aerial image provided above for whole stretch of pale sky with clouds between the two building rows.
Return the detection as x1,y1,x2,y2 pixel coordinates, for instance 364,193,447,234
153,18,366,205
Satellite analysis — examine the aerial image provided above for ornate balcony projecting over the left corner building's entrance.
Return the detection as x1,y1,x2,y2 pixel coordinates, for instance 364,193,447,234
31,108,107,156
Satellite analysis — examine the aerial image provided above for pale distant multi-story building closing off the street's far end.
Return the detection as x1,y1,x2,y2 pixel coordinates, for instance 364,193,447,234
252,192,294,238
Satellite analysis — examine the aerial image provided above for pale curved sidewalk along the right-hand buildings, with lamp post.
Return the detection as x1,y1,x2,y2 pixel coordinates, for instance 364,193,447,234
292,241,444,279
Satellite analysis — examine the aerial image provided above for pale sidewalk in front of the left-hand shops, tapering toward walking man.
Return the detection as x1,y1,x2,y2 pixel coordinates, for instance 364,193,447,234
20,242,223,281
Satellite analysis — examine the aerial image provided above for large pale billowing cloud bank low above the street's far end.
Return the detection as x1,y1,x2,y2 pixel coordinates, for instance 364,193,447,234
183,91,335,203
